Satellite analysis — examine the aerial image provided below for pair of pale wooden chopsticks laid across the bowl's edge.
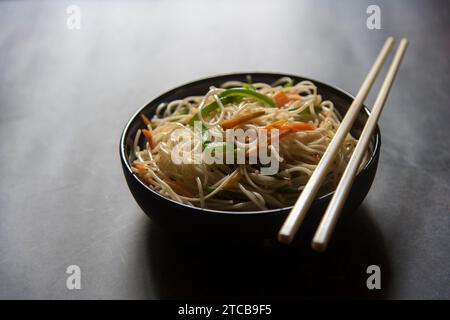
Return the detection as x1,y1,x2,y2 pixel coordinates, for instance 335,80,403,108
278,37,408,251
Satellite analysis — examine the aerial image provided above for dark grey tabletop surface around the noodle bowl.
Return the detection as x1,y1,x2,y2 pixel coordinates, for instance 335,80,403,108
0,0,450,299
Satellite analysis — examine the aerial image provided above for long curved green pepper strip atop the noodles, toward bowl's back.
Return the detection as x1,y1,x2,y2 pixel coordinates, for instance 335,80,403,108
188,88,276,126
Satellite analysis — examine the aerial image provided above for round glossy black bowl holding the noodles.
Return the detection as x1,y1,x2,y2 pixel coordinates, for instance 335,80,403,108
120,73,381,240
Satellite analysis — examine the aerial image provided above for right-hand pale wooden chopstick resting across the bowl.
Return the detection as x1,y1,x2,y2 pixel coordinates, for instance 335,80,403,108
311,39,408,251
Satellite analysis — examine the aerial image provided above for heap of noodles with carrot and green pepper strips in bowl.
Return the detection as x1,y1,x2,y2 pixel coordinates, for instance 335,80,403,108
132,77,367,211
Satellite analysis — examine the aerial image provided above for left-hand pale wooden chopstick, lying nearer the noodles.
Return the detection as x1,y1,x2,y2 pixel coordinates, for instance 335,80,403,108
278,37,394,244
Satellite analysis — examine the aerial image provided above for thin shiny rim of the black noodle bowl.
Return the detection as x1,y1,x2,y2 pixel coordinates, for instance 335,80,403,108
119,71,381,215
